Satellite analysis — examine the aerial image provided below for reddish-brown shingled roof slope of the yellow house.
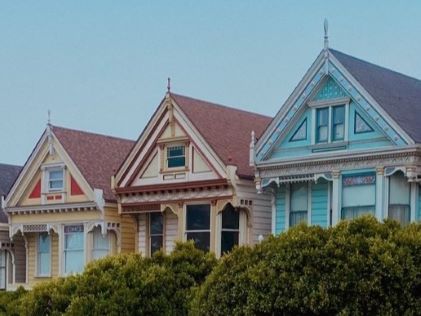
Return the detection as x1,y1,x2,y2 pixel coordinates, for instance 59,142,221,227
51,126,135,201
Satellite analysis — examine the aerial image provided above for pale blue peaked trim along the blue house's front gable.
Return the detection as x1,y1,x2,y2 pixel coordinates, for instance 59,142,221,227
255,51,414,164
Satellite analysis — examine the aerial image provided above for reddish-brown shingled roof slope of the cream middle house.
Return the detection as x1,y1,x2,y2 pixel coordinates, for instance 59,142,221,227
171,93,272,178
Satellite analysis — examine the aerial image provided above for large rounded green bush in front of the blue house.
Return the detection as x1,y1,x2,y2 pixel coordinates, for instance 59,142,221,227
191,217,421,315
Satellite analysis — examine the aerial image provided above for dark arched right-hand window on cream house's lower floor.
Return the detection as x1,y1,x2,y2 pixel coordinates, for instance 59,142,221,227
221,204,240,254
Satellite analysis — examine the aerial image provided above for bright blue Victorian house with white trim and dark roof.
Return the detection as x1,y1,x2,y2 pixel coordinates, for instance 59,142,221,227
250,30,421,233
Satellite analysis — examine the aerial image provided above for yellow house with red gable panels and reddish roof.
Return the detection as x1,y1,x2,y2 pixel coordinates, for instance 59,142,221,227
4,125,135,287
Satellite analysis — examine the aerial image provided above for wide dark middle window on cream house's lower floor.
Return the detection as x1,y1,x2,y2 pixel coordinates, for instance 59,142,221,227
186,204,210,251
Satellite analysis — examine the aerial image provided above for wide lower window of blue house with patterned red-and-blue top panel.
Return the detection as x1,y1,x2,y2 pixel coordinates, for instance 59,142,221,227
342,173,376,219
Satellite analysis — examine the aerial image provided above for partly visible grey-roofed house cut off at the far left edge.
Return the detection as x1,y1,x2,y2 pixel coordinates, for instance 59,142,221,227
0,164,26,291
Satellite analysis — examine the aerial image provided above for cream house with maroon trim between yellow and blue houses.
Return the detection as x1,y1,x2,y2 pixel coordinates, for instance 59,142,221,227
112,92,271,256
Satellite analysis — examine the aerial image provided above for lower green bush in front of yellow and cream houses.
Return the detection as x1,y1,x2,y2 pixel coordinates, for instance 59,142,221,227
21,243,216,315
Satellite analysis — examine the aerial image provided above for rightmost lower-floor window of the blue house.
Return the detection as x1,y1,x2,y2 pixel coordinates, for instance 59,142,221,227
388,172,411,225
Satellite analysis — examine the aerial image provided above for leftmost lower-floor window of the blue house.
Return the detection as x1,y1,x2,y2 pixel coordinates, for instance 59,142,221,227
289,182,308,227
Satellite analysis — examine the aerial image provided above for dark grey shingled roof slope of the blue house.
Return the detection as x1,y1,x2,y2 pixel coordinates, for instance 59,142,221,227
329,49,421,143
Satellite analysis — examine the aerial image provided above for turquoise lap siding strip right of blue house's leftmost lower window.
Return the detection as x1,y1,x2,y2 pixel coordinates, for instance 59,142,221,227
311,182,328,227
